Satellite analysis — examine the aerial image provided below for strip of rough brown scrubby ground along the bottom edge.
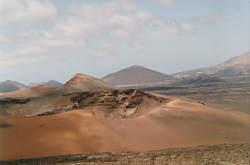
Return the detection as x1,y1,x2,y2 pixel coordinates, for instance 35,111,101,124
0,144,249,165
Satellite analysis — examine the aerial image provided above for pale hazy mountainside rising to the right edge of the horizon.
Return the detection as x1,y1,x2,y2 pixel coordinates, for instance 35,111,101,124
174,52,250,78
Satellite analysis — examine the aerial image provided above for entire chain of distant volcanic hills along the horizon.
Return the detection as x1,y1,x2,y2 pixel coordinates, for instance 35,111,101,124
0,52,250,93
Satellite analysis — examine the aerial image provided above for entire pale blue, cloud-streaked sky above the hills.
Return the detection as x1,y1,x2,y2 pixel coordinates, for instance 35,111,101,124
0,0,250,83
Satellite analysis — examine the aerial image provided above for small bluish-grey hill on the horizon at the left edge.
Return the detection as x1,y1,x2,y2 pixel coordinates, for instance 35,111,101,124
0,80,26,93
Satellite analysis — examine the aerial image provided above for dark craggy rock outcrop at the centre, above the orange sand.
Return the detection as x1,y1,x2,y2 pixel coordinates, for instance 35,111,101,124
71,89,166,118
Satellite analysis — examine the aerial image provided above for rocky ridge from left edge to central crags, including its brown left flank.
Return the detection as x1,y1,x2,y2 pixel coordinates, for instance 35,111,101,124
0,89,166,118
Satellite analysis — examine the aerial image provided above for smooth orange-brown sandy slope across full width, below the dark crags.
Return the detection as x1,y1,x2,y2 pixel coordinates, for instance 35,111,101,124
0,99,249,160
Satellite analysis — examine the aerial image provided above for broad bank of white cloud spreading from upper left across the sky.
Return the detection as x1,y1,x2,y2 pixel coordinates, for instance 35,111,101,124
0,0,223,66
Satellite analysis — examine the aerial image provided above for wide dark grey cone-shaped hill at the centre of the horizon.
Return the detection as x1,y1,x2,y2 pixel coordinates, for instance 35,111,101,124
102,65,175,86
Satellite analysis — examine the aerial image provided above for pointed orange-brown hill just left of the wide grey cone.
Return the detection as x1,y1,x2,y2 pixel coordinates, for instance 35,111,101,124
64,73,114,91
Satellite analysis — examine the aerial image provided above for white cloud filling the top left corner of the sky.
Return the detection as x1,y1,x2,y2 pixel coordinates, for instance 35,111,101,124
0,0,57,25
